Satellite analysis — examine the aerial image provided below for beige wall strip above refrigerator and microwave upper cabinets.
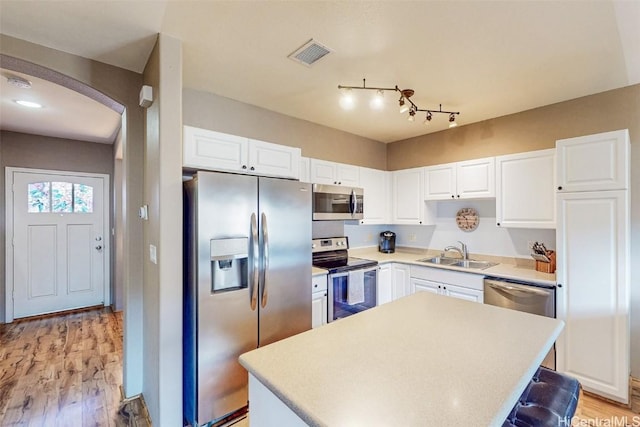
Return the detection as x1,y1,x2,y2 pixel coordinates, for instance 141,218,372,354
183,89,387,169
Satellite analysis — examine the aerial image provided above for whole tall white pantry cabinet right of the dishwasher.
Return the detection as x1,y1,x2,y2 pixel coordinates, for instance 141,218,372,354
556,129,630,403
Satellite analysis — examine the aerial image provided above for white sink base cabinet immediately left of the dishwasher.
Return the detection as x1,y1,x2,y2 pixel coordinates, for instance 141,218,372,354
411,266,484,303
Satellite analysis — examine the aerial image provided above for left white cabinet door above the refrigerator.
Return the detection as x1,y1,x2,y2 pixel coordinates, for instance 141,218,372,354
182,126,249,172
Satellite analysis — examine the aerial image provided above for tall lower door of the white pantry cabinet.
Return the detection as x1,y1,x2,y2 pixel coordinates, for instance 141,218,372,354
556,190,630,403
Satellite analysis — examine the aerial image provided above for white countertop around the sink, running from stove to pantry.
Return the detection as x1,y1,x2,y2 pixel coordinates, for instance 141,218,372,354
349,247,556,286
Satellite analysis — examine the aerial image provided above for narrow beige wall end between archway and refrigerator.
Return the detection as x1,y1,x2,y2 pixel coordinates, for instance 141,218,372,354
143,34,182,427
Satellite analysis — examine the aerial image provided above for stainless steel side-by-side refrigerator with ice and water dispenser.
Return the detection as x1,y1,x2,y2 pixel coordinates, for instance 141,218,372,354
183,171,311,425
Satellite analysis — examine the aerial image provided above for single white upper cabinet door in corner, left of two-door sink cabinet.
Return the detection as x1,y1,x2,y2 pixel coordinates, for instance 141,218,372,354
392,168,424,224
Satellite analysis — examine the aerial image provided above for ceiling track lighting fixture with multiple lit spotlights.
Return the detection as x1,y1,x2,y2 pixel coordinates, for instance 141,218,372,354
338,79,460,128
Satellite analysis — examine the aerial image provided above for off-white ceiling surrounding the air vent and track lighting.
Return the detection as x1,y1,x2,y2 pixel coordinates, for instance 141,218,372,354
0,0,640,142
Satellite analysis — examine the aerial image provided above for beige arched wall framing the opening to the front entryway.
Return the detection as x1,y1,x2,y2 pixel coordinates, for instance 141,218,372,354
0,34,143,396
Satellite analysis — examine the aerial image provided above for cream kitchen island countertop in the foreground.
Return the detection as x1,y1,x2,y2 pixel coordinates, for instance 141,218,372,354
240,292,563,426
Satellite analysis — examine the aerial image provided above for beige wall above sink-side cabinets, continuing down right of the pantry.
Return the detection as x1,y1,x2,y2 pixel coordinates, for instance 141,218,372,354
387,85,640,378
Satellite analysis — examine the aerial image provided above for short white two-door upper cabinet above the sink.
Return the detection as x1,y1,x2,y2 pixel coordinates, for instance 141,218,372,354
424,157,496,200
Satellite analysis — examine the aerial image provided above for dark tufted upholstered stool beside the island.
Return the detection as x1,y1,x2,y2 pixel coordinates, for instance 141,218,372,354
502,366,580,427
